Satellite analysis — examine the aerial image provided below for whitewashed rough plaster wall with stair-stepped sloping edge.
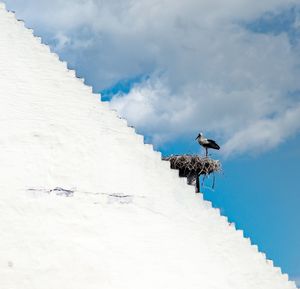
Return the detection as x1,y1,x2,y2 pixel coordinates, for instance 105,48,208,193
0,4,296,289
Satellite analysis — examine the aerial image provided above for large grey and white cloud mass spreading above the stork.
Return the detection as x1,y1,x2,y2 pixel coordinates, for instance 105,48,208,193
6,0,300,156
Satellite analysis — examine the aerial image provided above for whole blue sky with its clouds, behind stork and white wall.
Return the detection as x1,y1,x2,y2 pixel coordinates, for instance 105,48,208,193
4,0,300,286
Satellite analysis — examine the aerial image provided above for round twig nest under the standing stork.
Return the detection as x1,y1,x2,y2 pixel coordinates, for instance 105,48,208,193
163,155,221,184
